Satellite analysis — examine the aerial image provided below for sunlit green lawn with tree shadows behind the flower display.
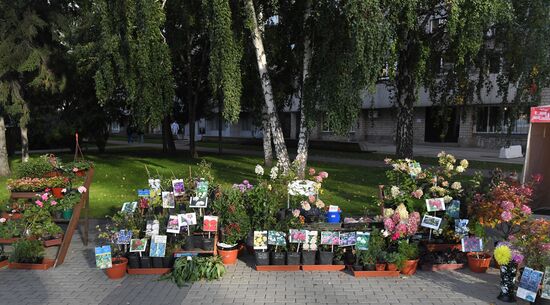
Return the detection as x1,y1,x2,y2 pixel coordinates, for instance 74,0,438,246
0,148,384,217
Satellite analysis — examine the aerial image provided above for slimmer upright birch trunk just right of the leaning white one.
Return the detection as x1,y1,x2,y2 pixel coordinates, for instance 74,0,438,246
294,0,312,178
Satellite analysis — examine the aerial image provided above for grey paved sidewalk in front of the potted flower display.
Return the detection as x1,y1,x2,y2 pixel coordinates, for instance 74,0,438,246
0,230,526,305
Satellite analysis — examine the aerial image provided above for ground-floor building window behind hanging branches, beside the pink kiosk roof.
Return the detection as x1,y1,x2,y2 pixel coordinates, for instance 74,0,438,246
476,106,529,134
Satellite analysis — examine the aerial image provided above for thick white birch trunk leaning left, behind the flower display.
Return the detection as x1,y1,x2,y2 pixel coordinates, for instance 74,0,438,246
246,0,290,173
